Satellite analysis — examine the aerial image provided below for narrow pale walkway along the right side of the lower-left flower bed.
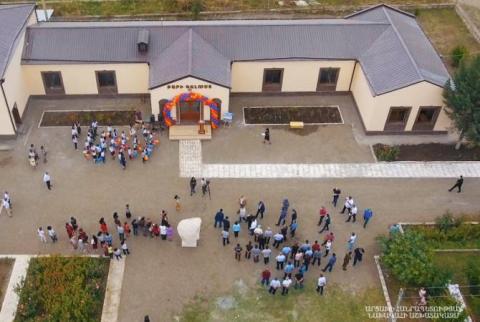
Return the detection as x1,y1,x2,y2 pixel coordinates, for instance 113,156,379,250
101,256,126,322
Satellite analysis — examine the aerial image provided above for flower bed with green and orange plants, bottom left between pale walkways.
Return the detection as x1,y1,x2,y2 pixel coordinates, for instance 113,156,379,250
15,256,109,322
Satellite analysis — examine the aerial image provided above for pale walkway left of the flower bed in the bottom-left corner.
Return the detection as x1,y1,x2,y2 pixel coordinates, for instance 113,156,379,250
0,255,31,322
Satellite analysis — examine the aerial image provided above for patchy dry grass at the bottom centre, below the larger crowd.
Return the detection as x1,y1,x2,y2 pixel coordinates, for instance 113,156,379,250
180,283,385,322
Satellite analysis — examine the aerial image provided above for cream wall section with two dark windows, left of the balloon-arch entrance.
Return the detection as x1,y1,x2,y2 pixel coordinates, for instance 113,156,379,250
22,63,149,95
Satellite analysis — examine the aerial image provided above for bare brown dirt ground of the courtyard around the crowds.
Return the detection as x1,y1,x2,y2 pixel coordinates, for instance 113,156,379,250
0,97,480,322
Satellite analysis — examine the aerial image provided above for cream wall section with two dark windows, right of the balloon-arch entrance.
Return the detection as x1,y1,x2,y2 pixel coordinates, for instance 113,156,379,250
232,60,355,92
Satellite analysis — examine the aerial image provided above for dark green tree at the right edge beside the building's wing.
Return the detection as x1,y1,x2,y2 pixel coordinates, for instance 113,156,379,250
443,56,480,149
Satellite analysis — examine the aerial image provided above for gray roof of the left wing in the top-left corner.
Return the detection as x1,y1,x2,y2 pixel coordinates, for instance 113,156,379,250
0,4,34,78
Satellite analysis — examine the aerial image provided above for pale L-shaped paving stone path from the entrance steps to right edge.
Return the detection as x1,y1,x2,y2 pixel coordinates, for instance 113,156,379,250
179,140,480,178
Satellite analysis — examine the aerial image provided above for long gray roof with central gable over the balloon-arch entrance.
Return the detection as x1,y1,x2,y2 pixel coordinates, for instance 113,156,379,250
23,5,449,95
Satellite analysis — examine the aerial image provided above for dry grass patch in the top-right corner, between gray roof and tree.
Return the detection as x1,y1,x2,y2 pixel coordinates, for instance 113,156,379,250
416,8,480,71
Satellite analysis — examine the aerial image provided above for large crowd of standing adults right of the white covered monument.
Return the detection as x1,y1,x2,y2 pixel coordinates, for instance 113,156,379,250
212,189,373,295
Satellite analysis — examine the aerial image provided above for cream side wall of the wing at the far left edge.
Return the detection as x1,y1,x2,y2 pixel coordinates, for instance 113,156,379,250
0,12,37,135
